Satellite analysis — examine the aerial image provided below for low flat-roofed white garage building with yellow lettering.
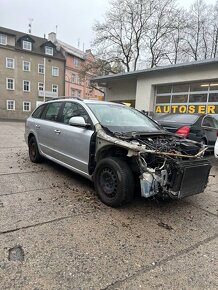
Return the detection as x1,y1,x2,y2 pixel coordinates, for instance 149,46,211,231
91,59,218,114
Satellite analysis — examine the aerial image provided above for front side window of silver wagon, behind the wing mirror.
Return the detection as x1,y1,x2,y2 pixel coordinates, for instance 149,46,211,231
61,102,91,124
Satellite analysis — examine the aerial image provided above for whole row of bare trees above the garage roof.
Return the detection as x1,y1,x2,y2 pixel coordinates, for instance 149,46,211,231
93,0,218,74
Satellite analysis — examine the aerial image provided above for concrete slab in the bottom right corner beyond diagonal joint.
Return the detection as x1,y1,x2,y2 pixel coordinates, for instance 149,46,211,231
118,238,218,290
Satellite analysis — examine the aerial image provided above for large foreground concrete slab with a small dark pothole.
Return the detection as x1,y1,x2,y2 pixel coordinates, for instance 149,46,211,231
0,208,217,289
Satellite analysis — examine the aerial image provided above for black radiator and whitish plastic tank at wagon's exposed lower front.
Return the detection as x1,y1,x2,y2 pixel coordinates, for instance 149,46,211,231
140,160,211,199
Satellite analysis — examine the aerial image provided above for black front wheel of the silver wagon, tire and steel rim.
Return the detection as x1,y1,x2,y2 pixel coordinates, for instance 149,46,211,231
94,157,134,207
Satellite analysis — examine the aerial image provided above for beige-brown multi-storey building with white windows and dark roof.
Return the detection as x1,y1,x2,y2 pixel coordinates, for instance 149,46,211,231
0,27,65,120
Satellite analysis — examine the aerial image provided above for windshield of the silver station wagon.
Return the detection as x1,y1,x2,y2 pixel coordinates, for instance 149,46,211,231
87,103,161,133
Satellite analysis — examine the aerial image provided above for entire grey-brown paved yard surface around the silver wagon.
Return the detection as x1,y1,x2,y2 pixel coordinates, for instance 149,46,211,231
0,122,218,290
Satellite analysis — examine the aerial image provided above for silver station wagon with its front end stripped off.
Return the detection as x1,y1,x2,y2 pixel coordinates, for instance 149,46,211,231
25,98,211,207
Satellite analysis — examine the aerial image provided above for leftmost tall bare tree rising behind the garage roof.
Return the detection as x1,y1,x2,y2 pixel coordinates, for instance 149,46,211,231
93,0,154,71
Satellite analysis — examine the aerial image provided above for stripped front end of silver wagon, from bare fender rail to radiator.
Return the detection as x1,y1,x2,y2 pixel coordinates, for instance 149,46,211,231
96,124,211,199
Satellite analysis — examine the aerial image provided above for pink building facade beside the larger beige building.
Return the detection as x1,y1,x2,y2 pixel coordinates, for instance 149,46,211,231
48,32,103,99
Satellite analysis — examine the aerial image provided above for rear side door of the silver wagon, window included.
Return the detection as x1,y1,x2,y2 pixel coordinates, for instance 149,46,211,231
36,102,64,159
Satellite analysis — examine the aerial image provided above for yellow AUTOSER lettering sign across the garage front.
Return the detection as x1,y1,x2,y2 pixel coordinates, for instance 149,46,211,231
155,105,218,114
